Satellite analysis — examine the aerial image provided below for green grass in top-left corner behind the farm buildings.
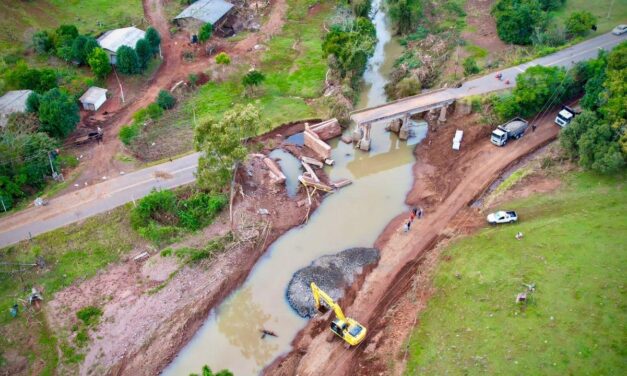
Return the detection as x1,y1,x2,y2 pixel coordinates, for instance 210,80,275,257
0,0,144,49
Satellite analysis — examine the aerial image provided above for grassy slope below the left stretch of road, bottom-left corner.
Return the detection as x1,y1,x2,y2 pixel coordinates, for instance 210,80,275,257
0,206,144,375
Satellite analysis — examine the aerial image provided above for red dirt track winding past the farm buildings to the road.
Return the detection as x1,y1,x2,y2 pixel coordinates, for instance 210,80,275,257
66,0,287,192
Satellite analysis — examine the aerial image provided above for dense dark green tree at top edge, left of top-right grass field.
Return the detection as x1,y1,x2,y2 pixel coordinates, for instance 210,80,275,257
492,0,546,45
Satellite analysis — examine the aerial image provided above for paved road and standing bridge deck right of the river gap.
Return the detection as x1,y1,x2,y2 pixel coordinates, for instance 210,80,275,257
351,33,627,123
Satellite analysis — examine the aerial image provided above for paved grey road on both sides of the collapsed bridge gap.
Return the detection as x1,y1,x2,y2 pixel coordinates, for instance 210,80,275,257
0,34,627,247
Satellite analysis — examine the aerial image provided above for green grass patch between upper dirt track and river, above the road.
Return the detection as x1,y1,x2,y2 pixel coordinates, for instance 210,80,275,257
187,0,330,131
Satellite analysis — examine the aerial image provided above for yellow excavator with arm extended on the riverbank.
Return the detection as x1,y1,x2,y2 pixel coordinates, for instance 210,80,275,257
311,282,367,346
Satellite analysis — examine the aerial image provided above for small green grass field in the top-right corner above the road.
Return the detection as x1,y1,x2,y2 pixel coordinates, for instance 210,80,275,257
555,0,627,35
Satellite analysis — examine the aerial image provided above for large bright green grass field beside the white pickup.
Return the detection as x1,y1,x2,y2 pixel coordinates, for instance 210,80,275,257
407,174,627,375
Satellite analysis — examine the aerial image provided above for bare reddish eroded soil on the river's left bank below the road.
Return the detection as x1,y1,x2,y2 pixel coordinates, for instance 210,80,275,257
46,123,327,376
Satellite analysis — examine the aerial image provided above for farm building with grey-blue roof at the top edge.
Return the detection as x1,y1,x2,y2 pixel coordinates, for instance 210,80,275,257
174,0,233,35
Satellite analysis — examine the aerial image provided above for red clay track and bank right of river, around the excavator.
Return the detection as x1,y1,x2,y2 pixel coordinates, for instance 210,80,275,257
265,107,559,376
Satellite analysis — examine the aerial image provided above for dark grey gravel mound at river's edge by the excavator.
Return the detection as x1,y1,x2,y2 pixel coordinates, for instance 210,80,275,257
286,248,379,317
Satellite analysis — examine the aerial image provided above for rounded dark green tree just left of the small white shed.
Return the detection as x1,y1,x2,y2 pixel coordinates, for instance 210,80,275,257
39,88,80,138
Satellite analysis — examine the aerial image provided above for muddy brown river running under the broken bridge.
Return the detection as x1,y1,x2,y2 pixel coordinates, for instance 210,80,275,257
163,0,418,376
